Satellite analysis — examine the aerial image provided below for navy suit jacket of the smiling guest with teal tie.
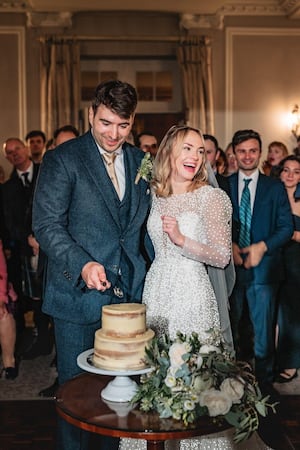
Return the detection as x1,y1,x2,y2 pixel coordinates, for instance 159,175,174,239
228,173,293,284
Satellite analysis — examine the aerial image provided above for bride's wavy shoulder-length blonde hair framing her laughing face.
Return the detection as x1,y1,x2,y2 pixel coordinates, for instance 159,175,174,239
152,125,208,197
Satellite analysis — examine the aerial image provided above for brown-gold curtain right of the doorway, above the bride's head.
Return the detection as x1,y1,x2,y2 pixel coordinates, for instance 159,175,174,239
178,36,214,134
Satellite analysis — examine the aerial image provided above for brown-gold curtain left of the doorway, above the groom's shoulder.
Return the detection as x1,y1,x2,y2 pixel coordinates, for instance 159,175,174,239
40,39,80,138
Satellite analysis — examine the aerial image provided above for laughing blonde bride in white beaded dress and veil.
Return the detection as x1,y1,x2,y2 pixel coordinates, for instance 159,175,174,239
119,126,268,450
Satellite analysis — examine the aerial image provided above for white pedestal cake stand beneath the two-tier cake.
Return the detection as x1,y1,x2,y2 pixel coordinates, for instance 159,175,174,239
77,349,152,402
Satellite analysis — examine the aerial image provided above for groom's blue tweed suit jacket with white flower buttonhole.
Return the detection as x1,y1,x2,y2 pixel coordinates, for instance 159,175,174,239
33,132,150,324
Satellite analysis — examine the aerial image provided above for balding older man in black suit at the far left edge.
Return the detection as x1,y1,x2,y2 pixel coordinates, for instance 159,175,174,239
1,137,40,343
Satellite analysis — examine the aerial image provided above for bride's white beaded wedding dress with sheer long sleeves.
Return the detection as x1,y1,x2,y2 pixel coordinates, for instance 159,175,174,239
120,185,268,450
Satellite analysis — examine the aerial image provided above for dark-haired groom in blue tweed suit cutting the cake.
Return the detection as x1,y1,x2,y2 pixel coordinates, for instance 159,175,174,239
33,81,151,450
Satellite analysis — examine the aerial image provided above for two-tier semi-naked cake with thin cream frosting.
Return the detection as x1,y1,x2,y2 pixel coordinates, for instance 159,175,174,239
93,303,154,371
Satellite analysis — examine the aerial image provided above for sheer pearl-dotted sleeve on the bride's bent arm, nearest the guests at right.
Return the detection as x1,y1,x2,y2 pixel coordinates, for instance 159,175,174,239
182,188,232,268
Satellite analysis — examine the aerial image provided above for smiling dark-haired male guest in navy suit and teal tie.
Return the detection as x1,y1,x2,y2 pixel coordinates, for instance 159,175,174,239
229,130,293,385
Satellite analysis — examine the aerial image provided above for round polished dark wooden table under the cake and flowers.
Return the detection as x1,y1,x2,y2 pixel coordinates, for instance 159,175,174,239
56,373,229,450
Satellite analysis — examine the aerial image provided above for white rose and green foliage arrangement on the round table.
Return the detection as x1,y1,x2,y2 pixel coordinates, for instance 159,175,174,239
132,330,276,442
